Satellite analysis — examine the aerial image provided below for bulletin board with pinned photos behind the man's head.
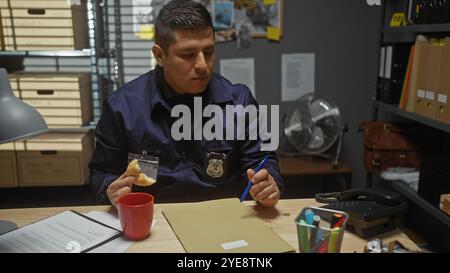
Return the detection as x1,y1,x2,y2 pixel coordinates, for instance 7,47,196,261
133,0,285,42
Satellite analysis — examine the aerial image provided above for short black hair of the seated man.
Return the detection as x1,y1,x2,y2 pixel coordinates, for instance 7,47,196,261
155,0,214,49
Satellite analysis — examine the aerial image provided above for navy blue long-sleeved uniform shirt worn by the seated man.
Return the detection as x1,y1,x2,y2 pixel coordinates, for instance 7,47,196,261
89,67,283,202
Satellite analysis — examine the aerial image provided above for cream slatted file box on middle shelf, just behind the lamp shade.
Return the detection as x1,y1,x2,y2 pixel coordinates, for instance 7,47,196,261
10,73,93,128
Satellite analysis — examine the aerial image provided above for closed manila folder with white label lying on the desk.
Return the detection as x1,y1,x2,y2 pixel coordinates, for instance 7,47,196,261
163,198,295,253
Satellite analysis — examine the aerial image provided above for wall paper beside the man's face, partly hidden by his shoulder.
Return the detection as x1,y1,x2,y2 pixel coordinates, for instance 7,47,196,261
220,58,256,97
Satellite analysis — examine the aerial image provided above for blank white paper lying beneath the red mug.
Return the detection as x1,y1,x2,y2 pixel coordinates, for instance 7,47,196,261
86,210,159,253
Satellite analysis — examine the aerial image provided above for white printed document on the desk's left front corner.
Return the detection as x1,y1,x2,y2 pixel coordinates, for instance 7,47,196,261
0,211,120,253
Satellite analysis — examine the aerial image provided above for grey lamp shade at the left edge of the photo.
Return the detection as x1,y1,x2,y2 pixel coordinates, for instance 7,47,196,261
0,68,48,144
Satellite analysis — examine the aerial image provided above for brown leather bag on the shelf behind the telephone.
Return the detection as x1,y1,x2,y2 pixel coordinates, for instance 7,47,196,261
360,122,420,172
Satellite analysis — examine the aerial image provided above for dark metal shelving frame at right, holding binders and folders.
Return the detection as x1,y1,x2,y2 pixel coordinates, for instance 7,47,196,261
366,0,450,251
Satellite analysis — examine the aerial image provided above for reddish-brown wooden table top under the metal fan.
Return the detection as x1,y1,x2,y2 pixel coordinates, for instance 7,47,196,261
278,155,352,189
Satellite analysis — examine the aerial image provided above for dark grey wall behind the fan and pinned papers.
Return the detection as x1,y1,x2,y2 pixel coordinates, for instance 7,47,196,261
216,0,382,186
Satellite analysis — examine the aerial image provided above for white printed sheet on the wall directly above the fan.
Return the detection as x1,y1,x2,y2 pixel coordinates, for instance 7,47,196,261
281,53,315,101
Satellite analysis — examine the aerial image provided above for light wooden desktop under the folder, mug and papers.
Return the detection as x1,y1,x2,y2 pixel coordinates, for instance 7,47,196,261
0,199,419,252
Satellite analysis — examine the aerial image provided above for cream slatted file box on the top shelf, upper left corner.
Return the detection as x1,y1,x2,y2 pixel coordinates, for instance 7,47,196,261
0,0,89,50
